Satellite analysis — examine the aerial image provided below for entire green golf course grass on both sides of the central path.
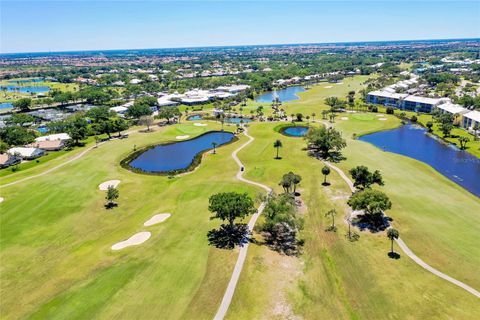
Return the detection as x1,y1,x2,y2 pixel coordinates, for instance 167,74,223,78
0,77,480,319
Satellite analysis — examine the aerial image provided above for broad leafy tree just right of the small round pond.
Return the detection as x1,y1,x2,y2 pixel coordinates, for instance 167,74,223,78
305,127,347,159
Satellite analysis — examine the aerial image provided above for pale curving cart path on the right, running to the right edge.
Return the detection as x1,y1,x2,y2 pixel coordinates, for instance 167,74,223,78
323,161,480,298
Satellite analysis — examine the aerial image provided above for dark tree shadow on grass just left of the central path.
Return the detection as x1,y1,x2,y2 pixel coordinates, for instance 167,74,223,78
207,224,251,249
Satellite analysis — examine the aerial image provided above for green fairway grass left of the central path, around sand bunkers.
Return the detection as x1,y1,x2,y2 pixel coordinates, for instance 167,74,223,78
0,123,256,319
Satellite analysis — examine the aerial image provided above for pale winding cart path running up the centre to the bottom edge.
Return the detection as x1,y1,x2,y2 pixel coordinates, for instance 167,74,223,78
214,129,272,320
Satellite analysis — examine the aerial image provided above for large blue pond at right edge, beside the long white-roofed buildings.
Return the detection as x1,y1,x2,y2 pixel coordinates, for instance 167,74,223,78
359,124,480,197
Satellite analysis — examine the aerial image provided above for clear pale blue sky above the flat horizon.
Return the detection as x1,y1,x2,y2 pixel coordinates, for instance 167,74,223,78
0,0,480,53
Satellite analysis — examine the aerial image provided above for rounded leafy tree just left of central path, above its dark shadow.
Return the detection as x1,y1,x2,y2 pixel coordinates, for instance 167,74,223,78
208,192,255,229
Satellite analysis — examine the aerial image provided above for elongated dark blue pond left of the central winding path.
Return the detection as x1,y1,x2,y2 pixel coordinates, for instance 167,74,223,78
122,131,235,174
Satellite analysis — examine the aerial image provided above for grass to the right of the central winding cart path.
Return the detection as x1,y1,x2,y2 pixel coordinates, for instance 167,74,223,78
225,119,480,319
